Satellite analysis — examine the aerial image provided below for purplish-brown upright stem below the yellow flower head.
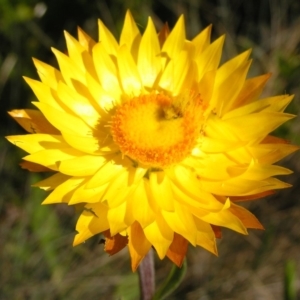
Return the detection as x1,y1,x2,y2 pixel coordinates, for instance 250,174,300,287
139,249,155,300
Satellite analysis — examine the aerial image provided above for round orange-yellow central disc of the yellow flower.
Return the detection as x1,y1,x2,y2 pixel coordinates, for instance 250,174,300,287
111,93,203,168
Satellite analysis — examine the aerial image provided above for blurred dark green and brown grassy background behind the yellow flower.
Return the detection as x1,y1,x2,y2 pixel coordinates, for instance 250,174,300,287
0,0,300,300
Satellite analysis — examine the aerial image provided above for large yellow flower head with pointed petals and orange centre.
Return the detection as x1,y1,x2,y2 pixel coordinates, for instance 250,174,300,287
8,12,298,270
